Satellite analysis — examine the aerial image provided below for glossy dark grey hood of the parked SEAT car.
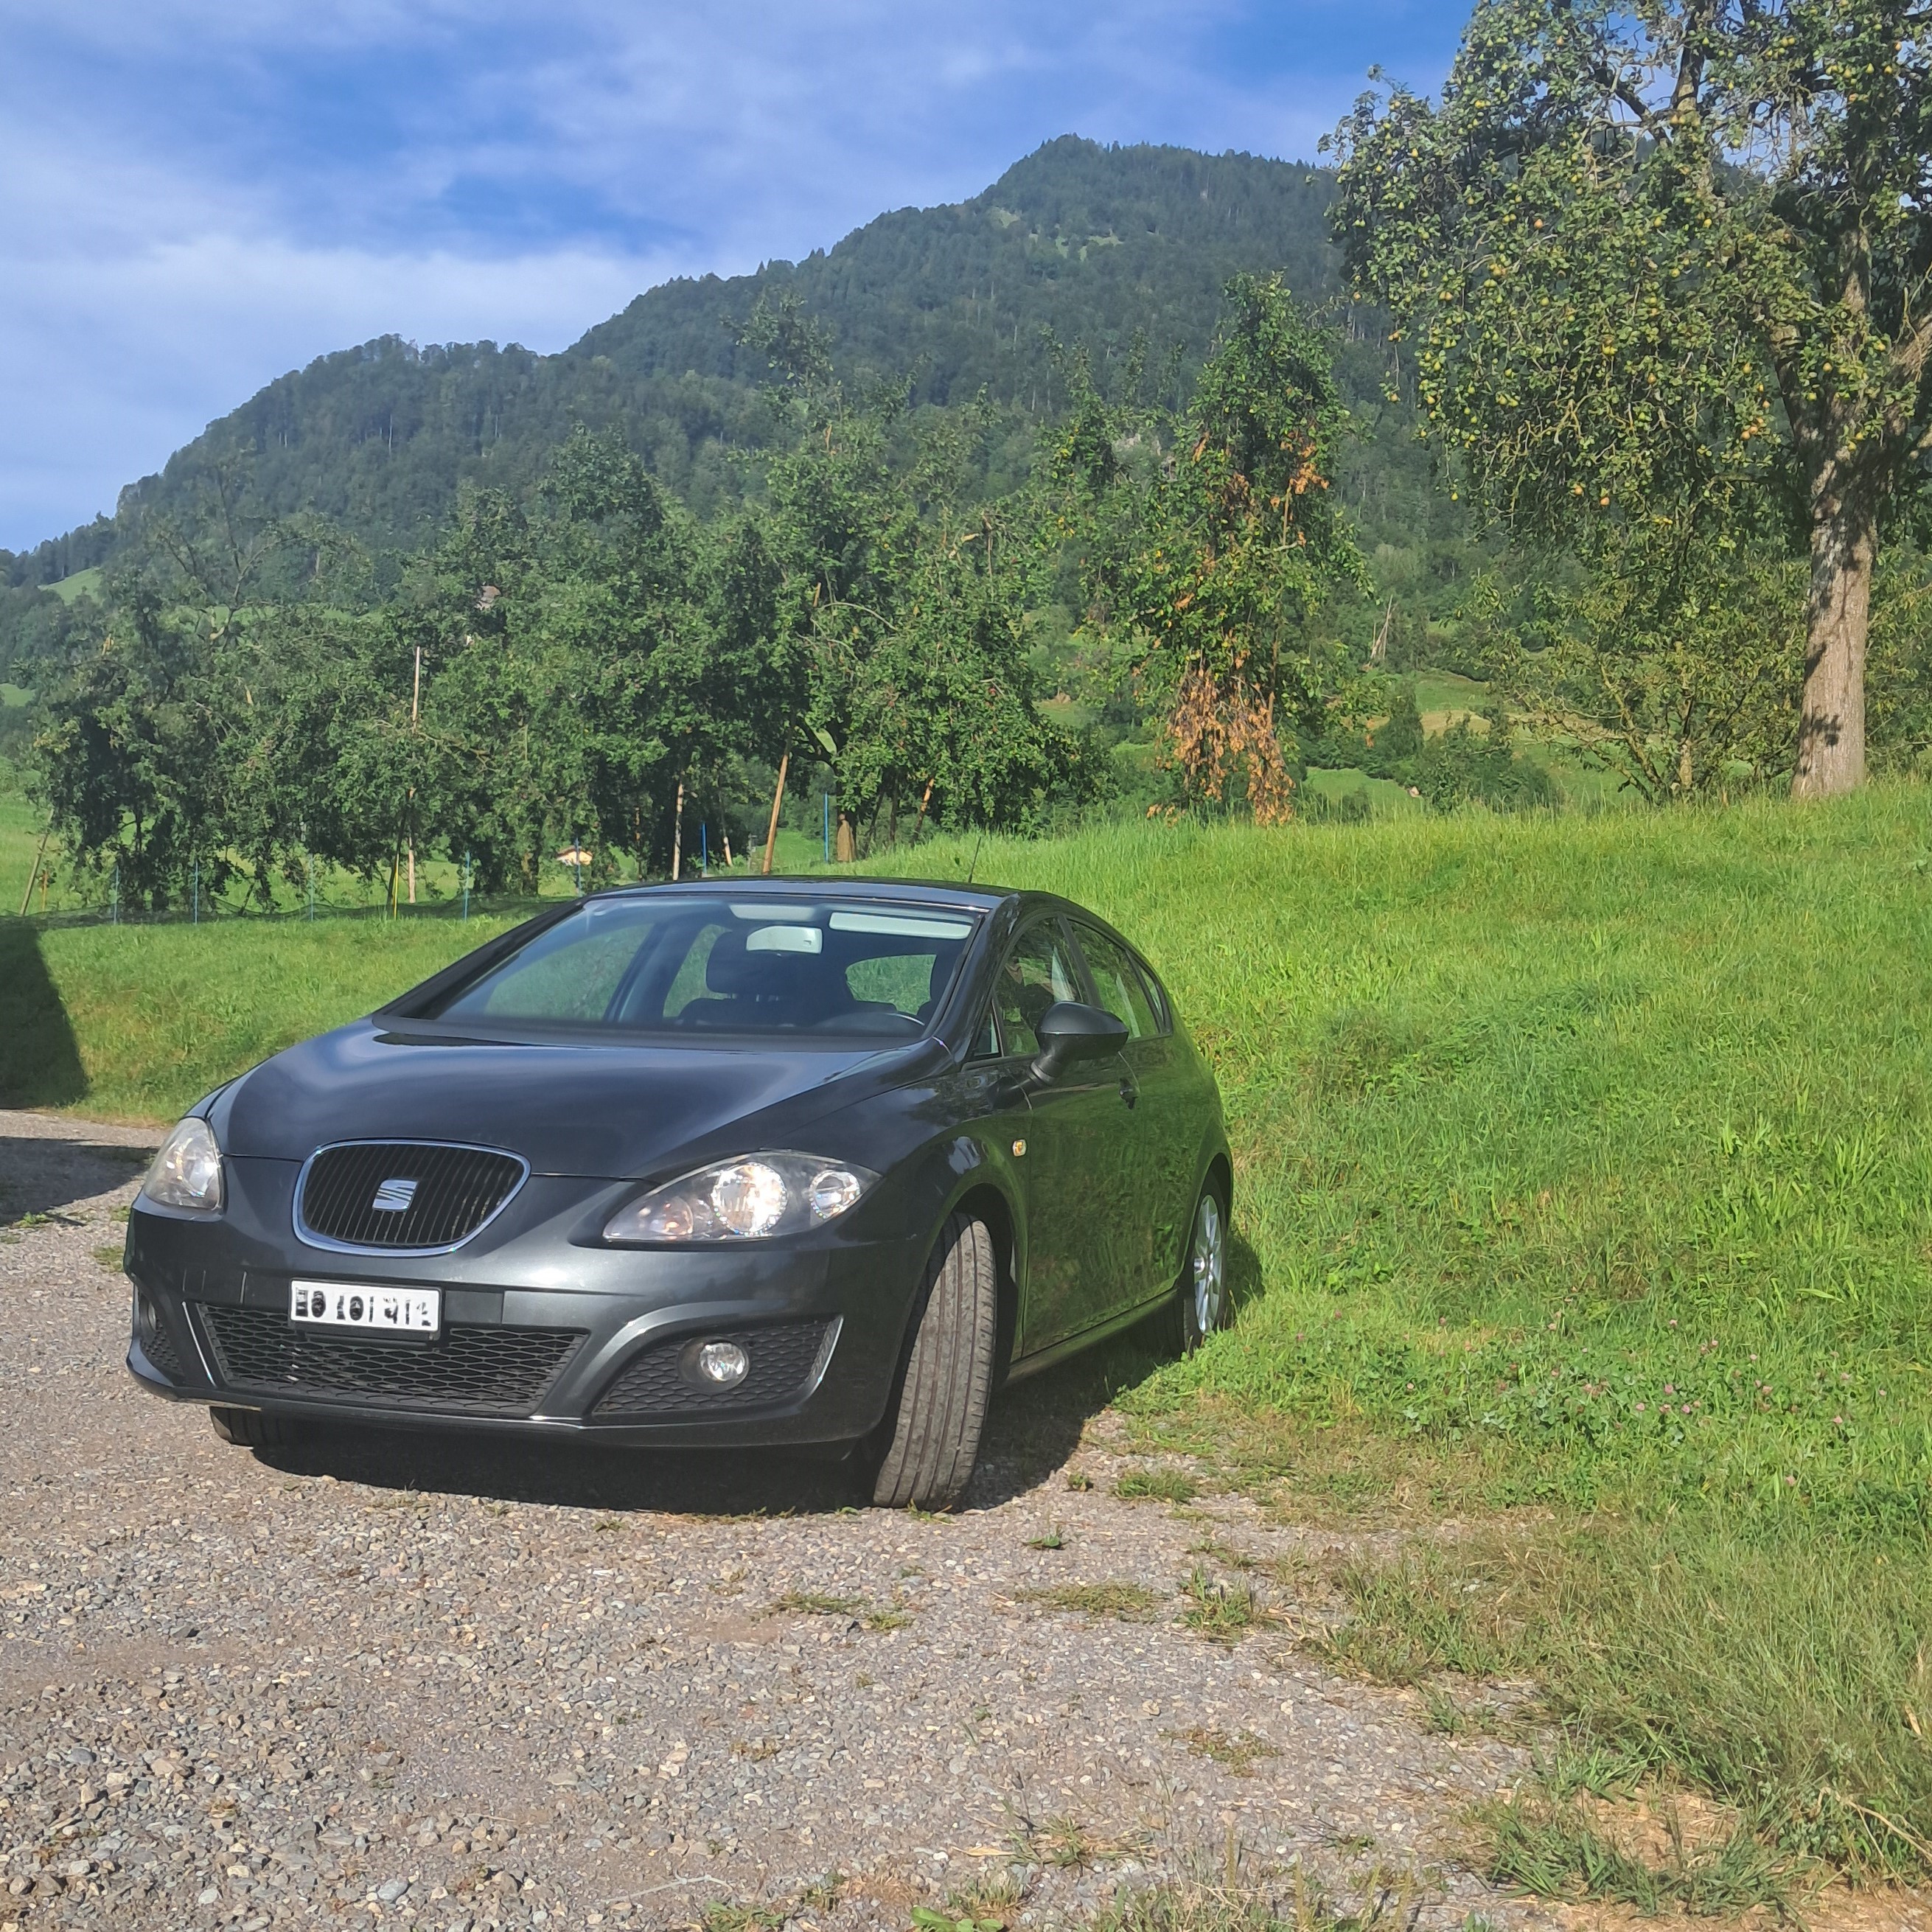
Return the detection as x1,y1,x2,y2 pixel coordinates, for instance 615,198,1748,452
211,1020,933,1180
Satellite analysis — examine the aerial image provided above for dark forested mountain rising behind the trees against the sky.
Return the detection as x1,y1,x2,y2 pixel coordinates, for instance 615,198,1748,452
0,135,1366,587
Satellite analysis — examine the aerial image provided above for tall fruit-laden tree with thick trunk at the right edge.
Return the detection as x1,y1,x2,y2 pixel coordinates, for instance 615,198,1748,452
1335,0,1932,796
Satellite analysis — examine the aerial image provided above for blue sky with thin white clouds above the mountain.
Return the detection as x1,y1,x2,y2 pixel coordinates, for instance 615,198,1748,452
0,0,1466,548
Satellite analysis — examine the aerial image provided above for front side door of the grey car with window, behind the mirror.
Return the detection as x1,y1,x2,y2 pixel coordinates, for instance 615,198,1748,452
993,918,1144,1354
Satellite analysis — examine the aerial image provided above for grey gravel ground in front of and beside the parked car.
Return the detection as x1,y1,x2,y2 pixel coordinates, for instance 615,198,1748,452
0,1113,1524,1932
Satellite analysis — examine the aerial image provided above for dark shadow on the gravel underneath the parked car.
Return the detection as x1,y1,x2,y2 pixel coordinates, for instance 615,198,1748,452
255,1331,1159,1516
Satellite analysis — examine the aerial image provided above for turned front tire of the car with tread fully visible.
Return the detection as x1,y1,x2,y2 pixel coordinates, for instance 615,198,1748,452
871,1213,999,1509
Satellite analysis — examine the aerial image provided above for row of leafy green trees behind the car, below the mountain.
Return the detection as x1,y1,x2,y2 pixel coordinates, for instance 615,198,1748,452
33,260,1391,892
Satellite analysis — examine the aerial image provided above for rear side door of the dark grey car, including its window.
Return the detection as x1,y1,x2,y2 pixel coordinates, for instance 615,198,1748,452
1074,920,1202,1300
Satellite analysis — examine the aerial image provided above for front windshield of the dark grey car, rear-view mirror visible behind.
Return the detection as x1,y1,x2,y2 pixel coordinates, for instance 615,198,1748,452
423,893,977,1039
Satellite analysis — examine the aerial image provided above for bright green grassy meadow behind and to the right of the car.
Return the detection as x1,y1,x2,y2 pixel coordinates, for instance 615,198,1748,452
0,788,1932,1870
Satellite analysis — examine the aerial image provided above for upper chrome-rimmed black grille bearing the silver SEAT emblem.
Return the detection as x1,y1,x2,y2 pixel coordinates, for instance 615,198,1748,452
296,1140,529,1254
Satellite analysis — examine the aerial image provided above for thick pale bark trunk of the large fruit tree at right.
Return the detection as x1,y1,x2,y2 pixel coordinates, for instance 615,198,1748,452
1791,489,1878,798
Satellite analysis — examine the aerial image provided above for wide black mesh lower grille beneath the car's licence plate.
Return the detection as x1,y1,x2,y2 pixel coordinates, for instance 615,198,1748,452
201,1302,584,1416
